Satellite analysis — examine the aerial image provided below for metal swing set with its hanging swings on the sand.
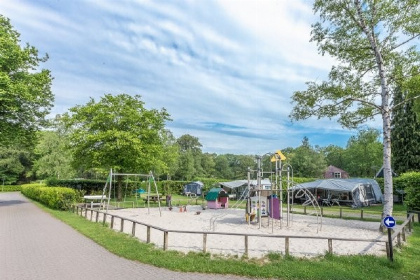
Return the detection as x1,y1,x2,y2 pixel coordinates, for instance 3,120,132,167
100,168,162,216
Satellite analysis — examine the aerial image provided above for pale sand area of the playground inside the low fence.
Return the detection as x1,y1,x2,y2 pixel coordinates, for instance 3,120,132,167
104,206,386,258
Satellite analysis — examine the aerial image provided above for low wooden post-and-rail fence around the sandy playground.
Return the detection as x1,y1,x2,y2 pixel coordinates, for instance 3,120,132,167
73,206,414,257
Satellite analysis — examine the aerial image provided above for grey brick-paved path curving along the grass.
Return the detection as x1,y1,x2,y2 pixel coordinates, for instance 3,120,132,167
0,192,256,280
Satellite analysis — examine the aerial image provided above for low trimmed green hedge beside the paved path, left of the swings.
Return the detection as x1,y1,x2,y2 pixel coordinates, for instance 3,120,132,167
21,184,81,210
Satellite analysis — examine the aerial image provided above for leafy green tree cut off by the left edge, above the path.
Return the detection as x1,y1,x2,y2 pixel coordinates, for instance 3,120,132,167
0,15,54,145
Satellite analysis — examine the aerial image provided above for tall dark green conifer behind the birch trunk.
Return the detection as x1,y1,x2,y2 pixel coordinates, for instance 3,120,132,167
391,87,420,174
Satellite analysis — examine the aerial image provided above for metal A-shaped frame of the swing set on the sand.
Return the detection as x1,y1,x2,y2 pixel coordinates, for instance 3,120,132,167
100,168,162,216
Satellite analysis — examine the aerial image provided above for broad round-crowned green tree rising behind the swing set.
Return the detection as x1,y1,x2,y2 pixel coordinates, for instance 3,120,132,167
63,94,169,199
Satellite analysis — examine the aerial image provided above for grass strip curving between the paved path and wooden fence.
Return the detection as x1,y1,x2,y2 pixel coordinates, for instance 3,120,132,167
38,201,420,280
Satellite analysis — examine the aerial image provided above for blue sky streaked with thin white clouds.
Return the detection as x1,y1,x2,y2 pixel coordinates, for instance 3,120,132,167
0,0,379,155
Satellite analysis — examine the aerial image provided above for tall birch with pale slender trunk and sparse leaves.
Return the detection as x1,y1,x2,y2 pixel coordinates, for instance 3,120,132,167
290,0,420,219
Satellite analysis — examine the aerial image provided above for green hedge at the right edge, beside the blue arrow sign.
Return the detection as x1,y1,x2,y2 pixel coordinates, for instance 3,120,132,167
399,172,420,211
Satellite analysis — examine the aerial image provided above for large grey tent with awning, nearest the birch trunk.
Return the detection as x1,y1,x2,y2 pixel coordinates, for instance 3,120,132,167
291,178,383,207
